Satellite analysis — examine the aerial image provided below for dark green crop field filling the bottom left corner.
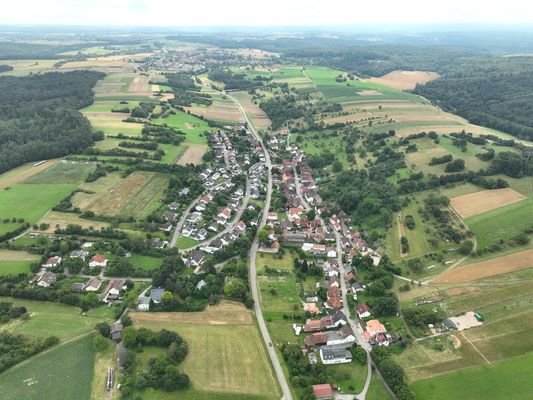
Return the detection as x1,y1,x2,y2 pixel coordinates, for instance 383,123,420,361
0,335,94,400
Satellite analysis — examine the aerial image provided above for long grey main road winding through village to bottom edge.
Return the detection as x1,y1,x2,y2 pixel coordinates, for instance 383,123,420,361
204,86,292,400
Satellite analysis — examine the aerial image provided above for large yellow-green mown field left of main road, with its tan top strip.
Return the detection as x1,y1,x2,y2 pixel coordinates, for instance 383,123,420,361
131,306,278,399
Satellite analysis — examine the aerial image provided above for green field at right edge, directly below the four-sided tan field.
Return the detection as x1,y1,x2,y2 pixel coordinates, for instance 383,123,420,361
465,198,533,248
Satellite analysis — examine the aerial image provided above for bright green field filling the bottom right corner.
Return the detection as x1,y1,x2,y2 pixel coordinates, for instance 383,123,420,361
411,353,533,400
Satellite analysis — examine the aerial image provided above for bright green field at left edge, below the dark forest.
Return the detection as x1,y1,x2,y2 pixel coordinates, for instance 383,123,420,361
0,183,78,224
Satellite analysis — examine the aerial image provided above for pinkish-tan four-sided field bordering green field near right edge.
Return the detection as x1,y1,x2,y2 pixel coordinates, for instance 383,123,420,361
451,188,526,218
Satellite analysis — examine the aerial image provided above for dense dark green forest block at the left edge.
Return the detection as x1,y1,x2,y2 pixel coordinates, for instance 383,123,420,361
0,71,104,173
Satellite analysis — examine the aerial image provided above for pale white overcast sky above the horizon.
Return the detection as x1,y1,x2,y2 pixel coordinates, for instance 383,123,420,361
0,0,533,27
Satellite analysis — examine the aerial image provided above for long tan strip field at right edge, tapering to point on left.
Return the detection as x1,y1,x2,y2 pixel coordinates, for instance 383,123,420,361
433,249,533,283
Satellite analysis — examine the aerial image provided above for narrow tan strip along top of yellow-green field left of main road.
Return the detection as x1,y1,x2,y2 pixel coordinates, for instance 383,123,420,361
129,301,253,325
